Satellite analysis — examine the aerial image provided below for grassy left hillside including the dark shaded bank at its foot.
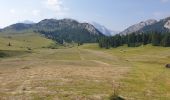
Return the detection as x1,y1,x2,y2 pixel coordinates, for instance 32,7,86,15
0,32,54,57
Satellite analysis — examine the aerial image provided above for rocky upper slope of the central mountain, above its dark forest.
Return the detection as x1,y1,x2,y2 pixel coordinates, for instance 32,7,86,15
34,19,101,35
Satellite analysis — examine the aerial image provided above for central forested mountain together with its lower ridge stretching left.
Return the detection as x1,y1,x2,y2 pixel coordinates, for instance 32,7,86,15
3,19,103,42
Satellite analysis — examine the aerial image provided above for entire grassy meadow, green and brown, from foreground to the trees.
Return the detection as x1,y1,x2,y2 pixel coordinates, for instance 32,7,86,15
0,33,170,100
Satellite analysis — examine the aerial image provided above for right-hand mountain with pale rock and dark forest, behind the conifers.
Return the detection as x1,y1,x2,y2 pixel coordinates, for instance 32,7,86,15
120,17,170,35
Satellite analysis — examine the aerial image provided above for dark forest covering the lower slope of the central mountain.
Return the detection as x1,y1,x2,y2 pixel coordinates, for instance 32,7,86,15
34,28,98,44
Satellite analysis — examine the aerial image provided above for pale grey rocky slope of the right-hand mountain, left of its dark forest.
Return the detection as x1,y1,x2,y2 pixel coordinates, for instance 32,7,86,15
120,19,157,35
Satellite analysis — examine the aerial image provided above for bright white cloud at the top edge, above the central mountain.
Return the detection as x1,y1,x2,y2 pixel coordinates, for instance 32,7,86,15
45,0,69,15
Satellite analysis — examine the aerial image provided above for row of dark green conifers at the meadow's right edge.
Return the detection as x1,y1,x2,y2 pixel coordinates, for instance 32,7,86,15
97,32,170,49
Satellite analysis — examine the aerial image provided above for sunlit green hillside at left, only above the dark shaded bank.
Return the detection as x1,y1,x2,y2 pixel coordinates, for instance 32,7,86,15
0,32,53,50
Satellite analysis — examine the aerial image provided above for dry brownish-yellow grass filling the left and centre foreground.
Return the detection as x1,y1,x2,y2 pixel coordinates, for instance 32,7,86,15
0,48,129,100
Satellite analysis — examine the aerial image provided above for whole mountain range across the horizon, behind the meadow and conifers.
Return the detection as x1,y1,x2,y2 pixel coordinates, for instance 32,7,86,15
0,17,170,42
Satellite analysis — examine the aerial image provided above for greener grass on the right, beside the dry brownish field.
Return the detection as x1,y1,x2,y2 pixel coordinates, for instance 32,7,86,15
81,45,170,100
